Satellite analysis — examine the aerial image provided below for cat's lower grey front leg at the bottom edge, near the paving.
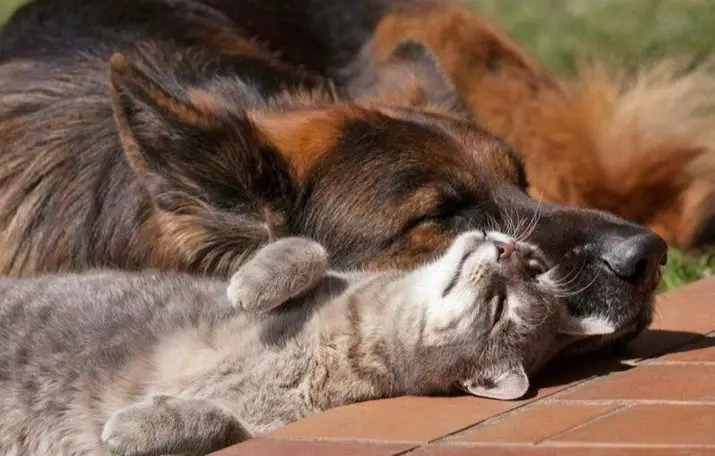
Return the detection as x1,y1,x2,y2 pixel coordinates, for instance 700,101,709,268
102,396,250,456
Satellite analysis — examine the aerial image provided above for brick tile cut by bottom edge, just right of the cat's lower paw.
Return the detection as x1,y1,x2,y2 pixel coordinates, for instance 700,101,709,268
212,439,411,456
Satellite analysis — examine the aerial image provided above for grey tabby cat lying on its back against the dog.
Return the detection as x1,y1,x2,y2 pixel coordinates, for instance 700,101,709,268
0,232,600,456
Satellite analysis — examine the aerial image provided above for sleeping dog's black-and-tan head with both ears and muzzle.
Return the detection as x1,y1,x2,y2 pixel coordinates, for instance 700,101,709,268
112,42,666,358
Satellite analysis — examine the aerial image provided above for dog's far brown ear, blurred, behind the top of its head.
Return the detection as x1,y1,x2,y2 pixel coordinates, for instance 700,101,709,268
348,40,469,116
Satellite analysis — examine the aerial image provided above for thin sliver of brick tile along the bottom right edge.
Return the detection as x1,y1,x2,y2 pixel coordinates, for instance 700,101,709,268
406,445,715,456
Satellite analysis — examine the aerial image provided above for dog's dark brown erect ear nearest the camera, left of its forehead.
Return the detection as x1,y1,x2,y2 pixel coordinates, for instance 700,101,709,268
110,54,300,210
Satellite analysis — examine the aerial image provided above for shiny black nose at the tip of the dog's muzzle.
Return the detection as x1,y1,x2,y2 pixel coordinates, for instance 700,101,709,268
601,231,668,283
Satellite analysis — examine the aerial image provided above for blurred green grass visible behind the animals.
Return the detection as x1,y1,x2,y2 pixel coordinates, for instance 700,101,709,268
0,0,715,290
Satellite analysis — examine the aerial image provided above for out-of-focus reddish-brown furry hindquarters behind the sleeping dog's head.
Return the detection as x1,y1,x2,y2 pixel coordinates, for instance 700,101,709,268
189,0,715,247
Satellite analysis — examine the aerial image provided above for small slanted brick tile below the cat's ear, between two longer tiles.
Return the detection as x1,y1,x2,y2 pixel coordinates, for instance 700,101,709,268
450,404,617,443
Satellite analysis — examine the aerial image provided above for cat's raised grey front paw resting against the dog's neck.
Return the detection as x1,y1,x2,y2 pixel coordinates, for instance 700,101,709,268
227,237,328,312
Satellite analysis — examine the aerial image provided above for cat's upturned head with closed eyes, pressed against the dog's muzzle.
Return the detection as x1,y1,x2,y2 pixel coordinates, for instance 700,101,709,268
410,231,613,399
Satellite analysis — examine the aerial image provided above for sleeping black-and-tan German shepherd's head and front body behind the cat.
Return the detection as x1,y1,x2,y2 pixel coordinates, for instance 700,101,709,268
0,0,666,353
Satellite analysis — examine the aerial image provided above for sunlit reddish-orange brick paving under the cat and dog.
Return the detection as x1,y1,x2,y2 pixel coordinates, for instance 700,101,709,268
216,278,715,456
